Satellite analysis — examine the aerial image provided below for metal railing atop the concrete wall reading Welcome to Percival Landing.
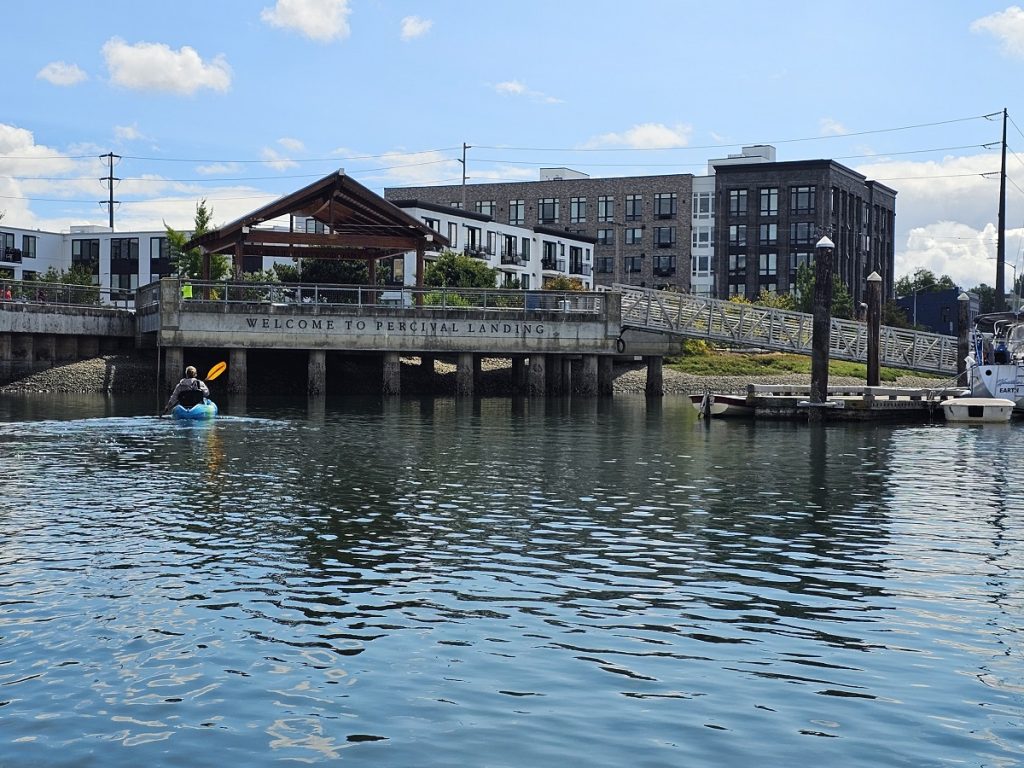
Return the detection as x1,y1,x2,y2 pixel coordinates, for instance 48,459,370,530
165,281,605,314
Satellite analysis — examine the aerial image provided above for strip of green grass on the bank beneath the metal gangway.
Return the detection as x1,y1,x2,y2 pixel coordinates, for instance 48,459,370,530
666,349,937,382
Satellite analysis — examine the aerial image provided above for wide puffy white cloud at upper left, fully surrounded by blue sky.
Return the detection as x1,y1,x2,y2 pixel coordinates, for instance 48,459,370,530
102,37,231,95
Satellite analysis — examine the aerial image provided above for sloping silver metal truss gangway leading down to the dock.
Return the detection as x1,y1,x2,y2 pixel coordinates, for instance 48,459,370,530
611,284,956,376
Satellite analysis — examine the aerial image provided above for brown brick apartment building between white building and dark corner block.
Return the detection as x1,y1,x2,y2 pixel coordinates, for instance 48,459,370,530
384,168,693,291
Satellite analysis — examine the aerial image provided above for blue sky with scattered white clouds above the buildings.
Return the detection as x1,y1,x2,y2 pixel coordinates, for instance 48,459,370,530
0,0,1024,288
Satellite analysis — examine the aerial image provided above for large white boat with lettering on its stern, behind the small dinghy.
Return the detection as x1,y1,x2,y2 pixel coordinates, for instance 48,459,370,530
967,312,1024,413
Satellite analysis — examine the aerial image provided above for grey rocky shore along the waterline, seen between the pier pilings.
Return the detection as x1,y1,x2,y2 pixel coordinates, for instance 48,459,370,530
0,355,943,395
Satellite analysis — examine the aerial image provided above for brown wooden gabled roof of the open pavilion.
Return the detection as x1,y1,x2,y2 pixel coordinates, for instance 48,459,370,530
185,170,449,268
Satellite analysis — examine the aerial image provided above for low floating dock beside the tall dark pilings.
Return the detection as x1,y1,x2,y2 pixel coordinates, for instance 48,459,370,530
746,384,970,421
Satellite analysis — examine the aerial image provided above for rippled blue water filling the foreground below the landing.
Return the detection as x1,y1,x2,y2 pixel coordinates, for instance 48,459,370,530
0,395,1024,768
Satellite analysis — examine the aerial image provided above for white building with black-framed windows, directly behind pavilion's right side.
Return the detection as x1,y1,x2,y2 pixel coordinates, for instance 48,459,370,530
391,200,595,291
